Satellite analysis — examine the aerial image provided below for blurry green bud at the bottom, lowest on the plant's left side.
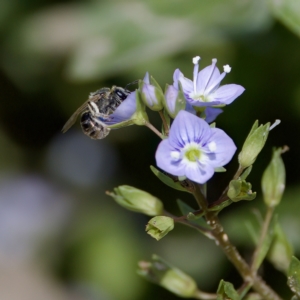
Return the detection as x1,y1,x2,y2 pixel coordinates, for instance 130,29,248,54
137,255,197,298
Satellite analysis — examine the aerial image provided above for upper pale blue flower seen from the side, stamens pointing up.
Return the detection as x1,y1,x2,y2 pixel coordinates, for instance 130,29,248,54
174,56,245,107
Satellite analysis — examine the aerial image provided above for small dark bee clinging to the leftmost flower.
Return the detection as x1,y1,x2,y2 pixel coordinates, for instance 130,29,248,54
62,86,131,140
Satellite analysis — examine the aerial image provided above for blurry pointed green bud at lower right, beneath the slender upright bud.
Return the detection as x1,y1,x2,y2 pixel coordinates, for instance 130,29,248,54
267,223,293,273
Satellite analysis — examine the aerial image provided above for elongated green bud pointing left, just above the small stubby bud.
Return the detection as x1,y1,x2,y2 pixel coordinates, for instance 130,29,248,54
106,185,163,216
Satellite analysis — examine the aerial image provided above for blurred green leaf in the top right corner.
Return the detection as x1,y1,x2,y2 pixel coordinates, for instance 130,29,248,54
269,0,300,36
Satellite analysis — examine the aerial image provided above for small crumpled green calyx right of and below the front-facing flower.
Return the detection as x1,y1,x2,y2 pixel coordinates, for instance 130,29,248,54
227,179,256,202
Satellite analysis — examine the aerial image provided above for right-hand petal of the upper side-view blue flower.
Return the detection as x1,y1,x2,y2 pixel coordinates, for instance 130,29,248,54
211,84,245,104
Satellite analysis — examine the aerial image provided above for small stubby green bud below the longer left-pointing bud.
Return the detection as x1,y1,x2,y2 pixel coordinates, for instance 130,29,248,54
146,216,174,241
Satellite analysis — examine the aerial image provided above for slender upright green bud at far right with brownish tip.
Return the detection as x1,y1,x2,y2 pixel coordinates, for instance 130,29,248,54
261,148,285,207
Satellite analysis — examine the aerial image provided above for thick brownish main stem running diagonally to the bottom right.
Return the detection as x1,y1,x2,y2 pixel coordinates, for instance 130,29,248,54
194,182,281,300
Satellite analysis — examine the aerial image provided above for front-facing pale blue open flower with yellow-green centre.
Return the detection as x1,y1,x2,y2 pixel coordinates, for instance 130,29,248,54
155,110,236,184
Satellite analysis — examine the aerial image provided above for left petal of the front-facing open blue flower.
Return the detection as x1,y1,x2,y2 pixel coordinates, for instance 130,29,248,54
155,139,185,176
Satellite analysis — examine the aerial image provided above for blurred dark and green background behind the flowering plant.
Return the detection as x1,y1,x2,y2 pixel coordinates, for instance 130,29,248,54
0,0,300,300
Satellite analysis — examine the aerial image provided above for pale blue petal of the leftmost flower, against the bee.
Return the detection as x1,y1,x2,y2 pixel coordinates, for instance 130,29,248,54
105,92,136,125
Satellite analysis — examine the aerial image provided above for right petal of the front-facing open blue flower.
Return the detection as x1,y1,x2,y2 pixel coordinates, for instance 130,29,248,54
206,128,236,168
